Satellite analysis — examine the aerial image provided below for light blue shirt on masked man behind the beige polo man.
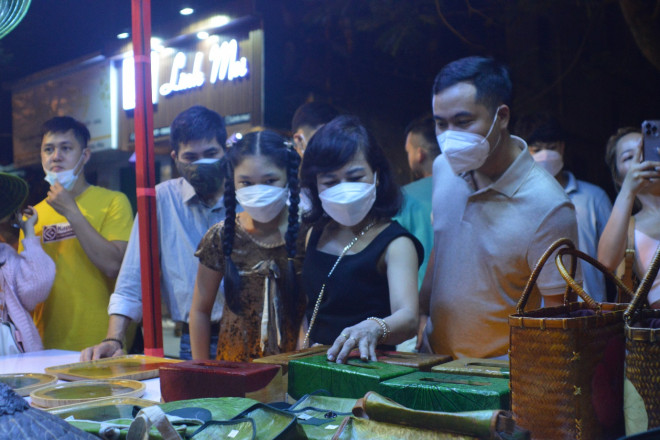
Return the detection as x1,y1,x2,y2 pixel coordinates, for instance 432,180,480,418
562,171,612,302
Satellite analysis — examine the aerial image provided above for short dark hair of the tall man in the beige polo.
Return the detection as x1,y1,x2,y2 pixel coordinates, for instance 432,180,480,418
433,56,513,112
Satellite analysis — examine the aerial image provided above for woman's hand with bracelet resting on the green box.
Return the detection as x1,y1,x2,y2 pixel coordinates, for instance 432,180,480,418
328,319,383,364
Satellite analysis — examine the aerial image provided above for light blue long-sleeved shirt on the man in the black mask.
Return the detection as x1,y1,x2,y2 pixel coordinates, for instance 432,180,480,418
108,178,229,322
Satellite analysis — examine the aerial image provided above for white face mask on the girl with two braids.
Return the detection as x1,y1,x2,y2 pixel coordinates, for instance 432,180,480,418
236,185,289,223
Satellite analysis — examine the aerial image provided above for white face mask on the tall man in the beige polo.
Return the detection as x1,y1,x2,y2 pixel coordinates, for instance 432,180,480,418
437,112,501,175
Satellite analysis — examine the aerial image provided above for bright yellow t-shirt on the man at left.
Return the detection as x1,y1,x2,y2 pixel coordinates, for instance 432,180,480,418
19,186,133,351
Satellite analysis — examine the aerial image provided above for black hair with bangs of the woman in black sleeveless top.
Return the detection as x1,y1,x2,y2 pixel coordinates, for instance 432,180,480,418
300,116,403,223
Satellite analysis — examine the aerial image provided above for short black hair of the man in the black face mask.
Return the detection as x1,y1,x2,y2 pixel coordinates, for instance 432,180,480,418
170,105,227,153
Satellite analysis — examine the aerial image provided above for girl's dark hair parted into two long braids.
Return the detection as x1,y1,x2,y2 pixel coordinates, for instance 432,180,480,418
222,130,300,314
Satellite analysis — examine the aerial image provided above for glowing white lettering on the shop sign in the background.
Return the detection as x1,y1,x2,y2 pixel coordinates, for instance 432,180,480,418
122,40,249,110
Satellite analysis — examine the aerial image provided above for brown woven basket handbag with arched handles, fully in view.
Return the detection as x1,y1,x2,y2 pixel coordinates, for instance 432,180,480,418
509,239,629,440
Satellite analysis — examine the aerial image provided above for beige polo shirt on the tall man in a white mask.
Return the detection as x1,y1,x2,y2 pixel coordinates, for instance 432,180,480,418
426,136,578,358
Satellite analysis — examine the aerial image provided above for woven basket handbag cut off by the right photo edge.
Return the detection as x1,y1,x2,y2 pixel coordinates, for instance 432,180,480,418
624,242,660,435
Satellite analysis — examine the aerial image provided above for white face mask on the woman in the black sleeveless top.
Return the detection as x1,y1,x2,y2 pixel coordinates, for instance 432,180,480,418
319,173,376,226
